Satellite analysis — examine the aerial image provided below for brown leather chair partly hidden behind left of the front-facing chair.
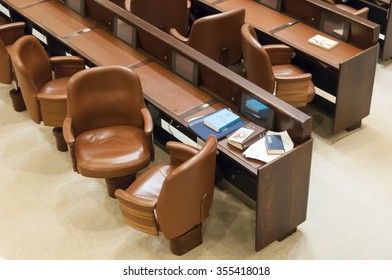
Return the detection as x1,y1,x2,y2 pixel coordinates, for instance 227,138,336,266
11,35,85,151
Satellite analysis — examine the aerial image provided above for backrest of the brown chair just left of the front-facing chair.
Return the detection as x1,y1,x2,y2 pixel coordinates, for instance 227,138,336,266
11,35,52,123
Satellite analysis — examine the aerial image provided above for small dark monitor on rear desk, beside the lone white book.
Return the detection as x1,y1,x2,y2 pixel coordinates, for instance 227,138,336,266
319,11,351,42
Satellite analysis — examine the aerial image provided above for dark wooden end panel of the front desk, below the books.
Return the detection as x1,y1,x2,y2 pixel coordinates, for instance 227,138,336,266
256,139,313,251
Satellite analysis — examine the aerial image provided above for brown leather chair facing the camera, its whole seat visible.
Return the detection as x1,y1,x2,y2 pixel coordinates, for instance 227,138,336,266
63,66,154,197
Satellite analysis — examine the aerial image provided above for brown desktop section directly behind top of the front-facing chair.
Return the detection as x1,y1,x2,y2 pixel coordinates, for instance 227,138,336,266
66,28,147,67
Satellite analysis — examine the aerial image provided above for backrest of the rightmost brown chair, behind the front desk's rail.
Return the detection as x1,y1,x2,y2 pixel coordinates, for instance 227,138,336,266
241,23,275,93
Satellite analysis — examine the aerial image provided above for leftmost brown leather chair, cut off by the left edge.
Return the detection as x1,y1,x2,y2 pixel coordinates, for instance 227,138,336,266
0,22,26,112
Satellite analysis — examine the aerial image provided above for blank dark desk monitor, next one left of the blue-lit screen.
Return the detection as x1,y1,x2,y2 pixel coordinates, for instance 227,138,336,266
171,51,199,86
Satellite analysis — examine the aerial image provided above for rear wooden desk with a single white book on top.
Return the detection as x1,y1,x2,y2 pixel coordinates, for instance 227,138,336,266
193,0,378,134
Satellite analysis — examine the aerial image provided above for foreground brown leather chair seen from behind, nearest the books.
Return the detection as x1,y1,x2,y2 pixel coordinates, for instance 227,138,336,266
115,136,217,255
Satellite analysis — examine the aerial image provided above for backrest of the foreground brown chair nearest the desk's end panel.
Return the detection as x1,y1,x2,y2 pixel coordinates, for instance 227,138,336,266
156,136,217,239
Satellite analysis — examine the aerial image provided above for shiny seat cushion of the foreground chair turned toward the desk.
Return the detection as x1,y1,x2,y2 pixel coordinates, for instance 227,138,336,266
126,163,175,202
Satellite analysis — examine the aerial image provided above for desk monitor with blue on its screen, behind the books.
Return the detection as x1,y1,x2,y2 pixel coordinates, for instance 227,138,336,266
240,92,275,130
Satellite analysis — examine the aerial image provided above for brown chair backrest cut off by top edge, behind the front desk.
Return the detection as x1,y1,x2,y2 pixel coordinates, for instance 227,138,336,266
130,0,189,36
